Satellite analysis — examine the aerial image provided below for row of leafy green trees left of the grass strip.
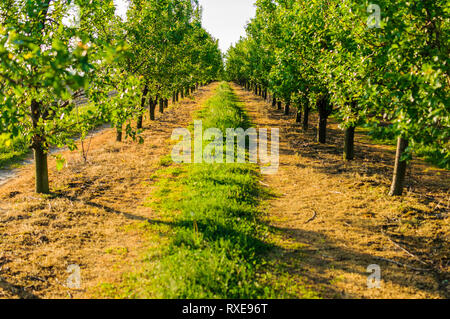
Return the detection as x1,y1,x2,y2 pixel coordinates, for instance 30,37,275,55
0,0,223,193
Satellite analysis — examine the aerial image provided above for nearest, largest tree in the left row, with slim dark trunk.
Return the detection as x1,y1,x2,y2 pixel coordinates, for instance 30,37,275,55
0,0,119,193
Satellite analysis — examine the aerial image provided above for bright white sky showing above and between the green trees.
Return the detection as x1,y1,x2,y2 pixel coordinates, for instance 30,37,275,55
114,0,256,53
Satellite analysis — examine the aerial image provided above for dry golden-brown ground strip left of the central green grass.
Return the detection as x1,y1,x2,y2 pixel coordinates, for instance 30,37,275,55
0,84,217,298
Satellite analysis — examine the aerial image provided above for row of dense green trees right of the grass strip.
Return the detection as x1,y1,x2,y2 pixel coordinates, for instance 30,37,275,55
226,0,450,195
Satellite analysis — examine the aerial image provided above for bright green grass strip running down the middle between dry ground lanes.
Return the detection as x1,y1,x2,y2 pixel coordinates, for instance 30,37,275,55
101,83,315,299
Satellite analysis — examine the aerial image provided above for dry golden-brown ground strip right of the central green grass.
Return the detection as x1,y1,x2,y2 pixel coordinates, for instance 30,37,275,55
233,85,450,298
